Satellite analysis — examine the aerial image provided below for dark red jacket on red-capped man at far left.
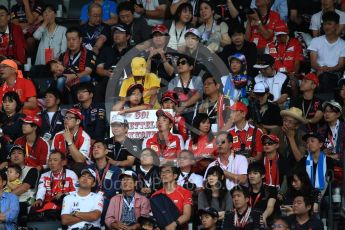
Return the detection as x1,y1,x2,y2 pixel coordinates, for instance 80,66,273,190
14,136,49,168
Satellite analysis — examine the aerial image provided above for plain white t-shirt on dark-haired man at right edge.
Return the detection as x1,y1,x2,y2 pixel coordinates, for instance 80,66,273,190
308,35,345,67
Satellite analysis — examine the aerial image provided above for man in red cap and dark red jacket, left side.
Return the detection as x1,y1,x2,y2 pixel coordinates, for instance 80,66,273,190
14,116,50,171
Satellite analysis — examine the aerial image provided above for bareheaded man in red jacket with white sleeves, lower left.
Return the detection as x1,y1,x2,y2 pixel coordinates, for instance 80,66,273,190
30,151,78,220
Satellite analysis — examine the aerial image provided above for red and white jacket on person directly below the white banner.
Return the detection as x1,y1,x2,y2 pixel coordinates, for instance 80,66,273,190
143,133,184,159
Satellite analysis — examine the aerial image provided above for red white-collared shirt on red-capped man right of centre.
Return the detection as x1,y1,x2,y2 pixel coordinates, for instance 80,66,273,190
229,122,263,157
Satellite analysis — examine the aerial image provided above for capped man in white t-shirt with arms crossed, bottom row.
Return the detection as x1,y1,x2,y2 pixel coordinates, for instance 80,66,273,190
61,169,103,230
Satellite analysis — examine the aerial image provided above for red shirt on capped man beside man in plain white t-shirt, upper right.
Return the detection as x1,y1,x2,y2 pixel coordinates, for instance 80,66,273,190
267,38,304,73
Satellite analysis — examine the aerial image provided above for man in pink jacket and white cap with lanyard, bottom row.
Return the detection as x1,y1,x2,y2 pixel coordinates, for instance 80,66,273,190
105,170,151,229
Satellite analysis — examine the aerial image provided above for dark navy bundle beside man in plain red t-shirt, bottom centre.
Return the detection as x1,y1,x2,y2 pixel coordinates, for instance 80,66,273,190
150,194,180,229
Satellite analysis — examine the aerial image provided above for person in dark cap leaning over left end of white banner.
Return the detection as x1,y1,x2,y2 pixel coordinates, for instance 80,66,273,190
113,84,150,115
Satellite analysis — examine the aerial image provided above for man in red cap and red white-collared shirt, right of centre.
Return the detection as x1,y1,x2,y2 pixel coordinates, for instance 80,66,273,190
229,102,263,161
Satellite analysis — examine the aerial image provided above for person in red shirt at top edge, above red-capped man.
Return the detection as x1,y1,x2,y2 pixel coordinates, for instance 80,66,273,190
246,0,281,53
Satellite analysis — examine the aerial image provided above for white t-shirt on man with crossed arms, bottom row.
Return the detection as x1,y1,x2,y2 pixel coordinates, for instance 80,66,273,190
61,192,103,230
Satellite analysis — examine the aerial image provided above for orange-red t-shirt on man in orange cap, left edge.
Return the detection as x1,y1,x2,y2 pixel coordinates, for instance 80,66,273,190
0,78,39,115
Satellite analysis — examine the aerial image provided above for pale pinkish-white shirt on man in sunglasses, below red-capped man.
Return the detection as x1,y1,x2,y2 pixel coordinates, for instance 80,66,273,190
204,154,248,191
